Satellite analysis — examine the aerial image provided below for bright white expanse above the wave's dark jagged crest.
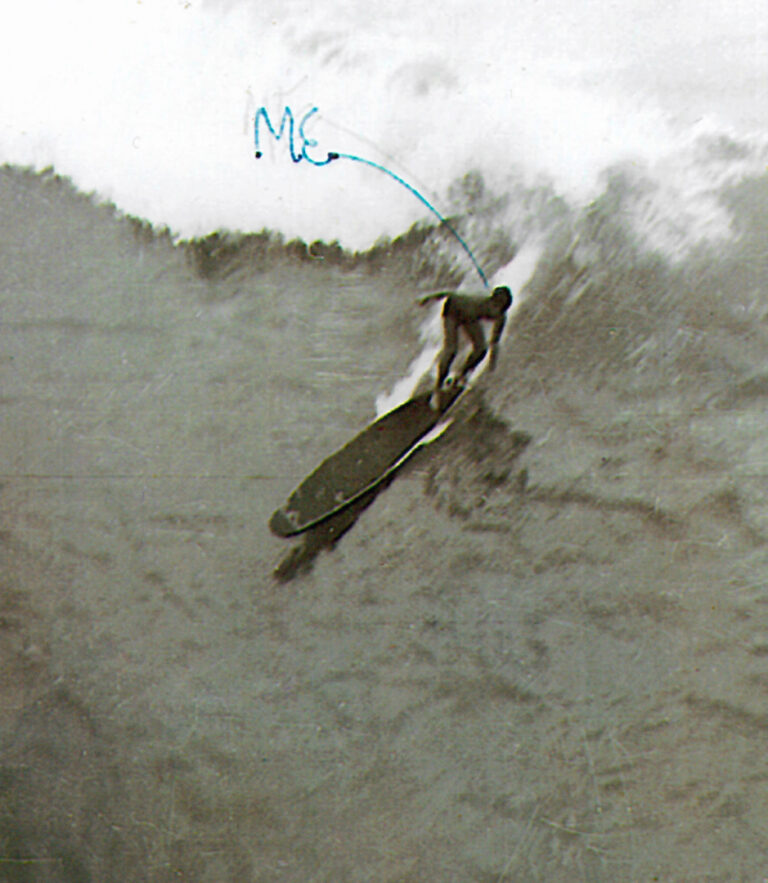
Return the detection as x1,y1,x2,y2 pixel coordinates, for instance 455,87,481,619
0,0,768,264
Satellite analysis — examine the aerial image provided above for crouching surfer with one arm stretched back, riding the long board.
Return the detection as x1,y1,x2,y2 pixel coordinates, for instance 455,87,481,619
419,285,512,409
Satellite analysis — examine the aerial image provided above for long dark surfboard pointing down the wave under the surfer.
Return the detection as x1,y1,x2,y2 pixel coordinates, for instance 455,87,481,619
269,386,467,537
